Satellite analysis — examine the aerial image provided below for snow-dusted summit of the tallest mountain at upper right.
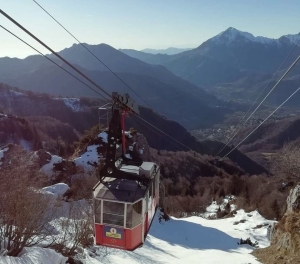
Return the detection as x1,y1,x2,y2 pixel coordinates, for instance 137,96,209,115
211,27,276,44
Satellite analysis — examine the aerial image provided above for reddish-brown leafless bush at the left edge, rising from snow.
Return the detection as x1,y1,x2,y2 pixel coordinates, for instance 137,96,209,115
0,146,50,256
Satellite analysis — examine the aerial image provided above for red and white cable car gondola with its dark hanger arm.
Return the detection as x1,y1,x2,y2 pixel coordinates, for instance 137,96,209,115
93,93,160,250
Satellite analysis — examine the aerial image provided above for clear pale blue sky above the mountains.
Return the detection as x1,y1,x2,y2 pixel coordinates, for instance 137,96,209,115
0,0,300,58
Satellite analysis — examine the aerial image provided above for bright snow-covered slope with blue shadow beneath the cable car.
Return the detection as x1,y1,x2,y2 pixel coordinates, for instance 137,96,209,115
0,206,272,264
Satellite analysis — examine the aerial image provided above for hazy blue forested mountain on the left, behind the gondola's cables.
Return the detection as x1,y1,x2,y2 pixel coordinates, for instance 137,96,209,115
0,44,243,129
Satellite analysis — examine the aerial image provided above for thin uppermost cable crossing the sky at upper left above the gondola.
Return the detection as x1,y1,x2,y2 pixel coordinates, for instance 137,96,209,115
33,0,153,110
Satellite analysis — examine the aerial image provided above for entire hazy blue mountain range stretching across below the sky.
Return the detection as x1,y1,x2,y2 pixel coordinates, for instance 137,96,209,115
0,28,300,132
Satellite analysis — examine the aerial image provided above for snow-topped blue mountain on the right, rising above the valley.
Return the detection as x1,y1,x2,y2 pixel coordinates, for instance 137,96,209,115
122,28,300,103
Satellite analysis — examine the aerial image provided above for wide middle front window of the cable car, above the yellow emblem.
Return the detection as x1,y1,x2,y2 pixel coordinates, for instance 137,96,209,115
103,201,124,226
